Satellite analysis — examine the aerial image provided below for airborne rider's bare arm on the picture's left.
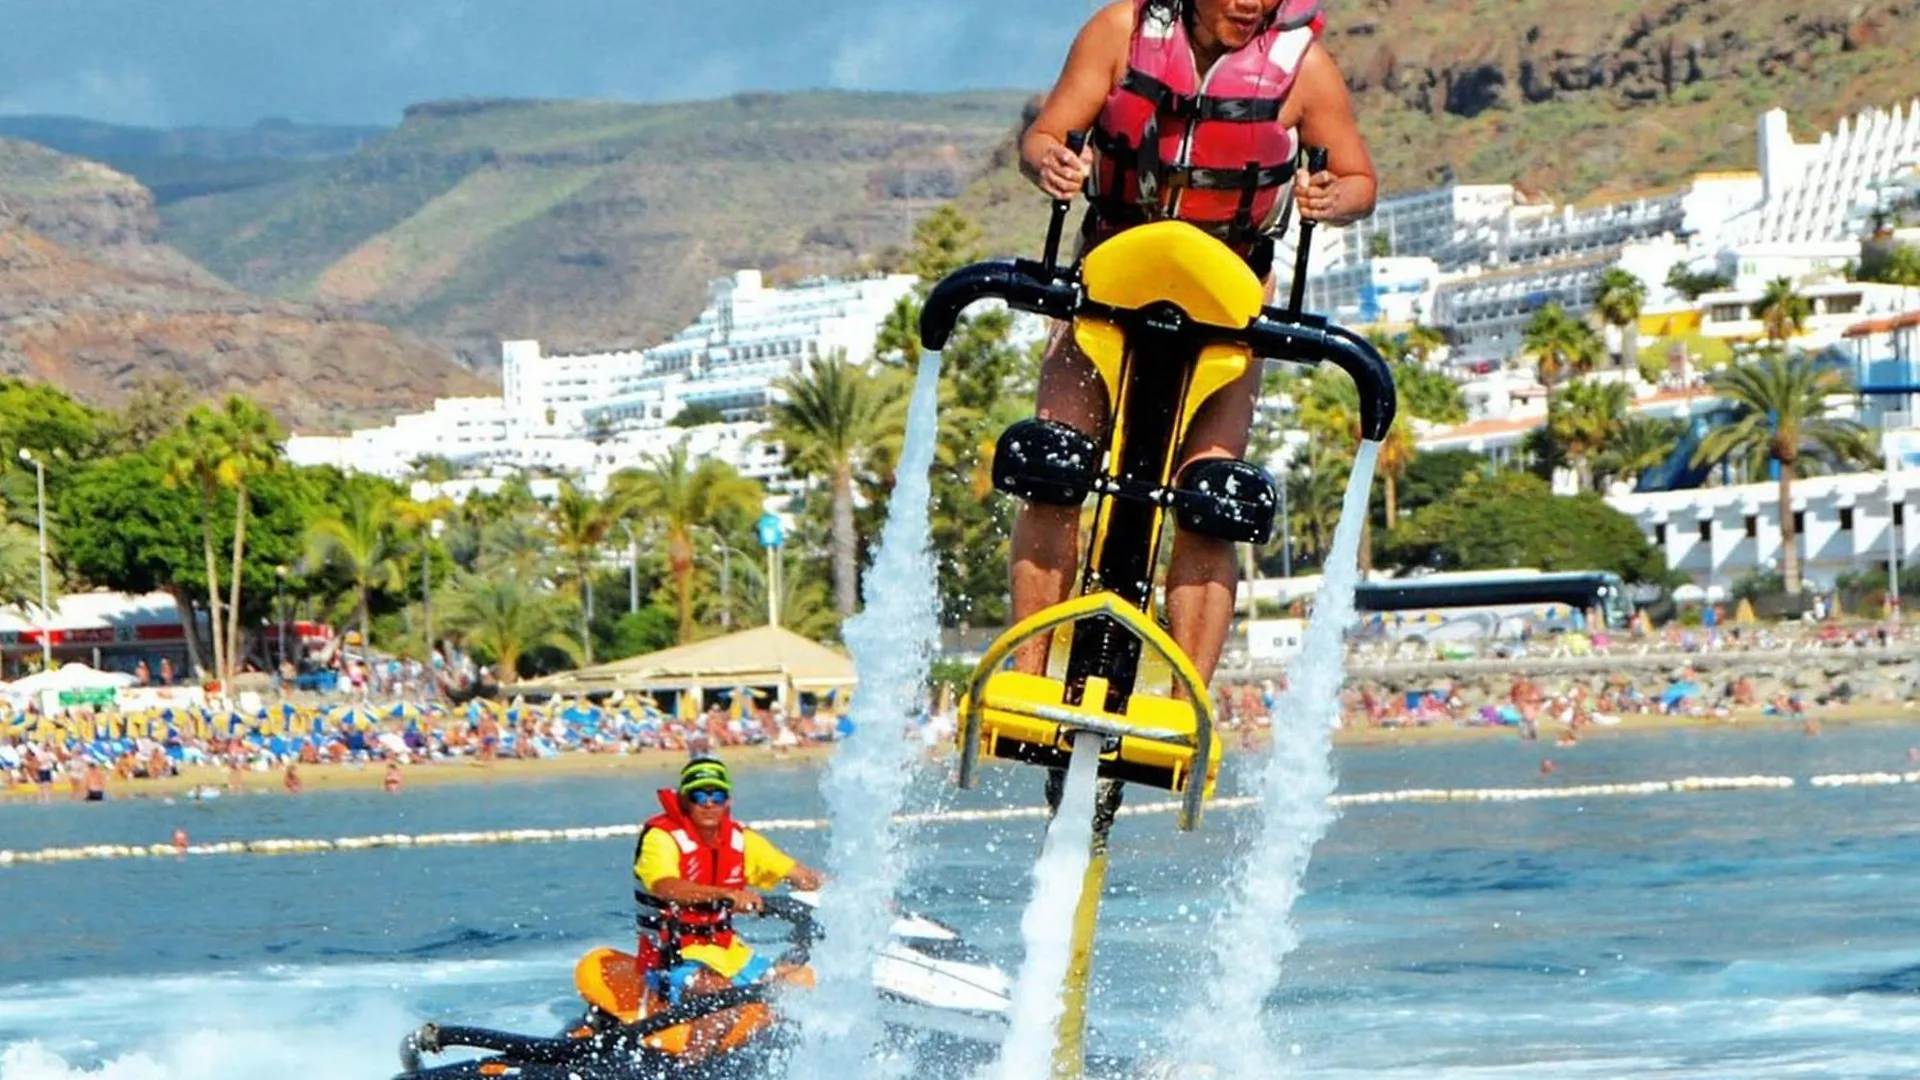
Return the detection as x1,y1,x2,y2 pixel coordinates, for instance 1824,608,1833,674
1020,0,1133,198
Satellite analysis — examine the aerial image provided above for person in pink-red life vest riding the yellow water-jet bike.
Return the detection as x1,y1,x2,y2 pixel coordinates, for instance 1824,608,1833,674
1012,0,1375,690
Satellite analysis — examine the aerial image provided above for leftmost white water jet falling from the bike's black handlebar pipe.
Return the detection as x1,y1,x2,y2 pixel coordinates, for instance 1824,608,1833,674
787,352,941,1080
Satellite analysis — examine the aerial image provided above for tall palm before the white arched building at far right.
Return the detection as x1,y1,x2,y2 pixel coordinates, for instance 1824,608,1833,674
1693,348,1874,596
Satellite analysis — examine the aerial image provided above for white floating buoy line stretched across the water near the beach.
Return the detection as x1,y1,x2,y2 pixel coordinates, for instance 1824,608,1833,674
0,771,1920,867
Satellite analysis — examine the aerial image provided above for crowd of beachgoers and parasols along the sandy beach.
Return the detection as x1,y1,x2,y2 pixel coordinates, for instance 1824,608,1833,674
0,623,1914,799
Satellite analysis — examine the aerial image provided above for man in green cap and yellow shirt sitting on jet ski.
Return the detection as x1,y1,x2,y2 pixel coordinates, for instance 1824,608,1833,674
634,757,824,1005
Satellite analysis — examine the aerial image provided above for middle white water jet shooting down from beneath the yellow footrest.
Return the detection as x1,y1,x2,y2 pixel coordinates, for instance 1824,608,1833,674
995,732,1100,1080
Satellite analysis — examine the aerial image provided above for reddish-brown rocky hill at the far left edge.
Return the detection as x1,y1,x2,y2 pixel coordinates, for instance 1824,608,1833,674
0,140,490,430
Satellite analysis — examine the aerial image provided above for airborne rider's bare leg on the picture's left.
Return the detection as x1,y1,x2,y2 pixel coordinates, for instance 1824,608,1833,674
1010,320,1108,675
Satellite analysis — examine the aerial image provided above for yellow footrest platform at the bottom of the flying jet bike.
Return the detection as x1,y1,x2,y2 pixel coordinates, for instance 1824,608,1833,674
960,671,1219,798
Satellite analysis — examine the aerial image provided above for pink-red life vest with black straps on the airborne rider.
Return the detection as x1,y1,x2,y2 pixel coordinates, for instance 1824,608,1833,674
1089,0,1327,254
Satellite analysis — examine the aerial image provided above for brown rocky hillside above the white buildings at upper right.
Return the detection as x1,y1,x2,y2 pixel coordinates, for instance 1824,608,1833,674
962,0,1920,250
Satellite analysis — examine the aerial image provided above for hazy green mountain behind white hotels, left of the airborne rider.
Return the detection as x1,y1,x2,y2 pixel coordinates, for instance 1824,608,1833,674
163,92,1021,363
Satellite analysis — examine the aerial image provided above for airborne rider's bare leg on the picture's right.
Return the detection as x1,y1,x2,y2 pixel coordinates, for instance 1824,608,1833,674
1167,353,1260,698
